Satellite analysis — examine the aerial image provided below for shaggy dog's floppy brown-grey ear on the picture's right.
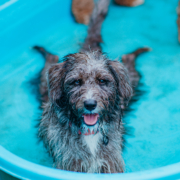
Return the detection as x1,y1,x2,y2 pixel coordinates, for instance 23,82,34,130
108,60,132,103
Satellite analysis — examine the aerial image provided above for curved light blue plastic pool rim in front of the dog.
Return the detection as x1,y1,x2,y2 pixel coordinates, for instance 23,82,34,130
0,146,180,180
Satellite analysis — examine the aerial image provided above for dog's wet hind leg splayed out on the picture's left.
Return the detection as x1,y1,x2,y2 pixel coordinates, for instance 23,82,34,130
33,46,59,102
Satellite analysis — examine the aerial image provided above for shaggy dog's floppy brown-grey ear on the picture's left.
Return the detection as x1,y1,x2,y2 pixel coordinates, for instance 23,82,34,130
47,62,65,103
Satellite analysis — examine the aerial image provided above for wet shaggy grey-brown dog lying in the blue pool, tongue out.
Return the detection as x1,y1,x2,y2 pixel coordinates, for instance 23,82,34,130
34,0,148,173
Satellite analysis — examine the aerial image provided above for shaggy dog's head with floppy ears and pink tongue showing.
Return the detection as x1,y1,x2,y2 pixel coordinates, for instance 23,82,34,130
48,52,132,133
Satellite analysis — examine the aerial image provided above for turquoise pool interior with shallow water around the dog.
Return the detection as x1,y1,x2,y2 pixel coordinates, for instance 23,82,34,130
0,0,180,176
